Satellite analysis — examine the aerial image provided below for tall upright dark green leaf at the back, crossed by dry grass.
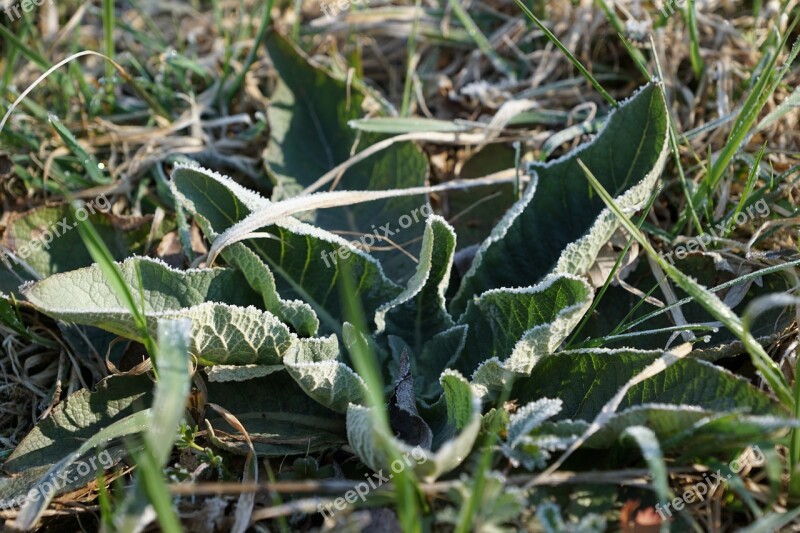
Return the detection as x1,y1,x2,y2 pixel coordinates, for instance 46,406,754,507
264,33,429,281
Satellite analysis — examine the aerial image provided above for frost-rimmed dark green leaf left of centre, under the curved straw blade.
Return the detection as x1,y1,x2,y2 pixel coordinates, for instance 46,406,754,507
172,167,400,333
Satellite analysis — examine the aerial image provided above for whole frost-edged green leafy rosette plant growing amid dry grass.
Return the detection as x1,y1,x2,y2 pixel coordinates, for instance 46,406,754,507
6,36,788,528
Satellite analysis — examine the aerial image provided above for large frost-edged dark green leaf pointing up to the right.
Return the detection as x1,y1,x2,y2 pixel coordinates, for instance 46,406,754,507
451,85,669,314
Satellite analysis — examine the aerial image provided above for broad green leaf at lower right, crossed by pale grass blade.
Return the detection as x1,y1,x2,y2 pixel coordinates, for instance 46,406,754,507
496,349,793,459
